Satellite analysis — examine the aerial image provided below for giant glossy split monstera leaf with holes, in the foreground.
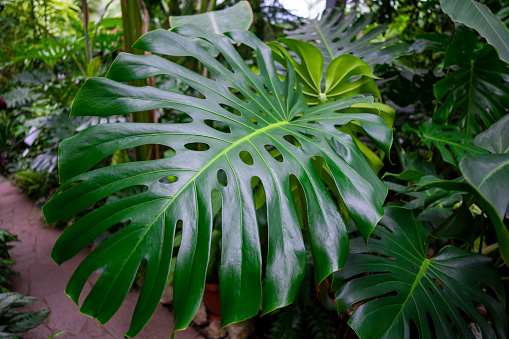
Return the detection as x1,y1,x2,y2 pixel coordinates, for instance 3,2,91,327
43,25,392,337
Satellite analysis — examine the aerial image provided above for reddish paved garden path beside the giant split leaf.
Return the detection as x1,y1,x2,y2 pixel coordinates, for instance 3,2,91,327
0,177,200,339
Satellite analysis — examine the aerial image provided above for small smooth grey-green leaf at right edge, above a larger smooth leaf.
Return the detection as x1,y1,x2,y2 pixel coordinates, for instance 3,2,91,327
474,115,509,154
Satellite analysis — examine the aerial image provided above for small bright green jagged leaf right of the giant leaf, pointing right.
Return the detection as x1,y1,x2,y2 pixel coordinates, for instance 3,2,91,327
403,119,486,166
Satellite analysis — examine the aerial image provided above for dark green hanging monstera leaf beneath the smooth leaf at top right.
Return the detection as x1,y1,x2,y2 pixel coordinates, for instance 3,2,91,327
433,26,509,134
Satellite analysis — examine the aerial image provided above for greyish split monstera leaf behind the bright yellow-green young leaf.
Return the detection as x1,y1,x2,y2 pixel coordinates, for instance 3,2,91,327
287,8,407,67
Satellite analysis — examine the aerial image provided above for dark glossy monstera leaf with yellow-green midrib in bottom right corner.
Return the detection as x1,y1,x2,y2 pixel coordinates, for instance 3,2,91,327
334,207,507,338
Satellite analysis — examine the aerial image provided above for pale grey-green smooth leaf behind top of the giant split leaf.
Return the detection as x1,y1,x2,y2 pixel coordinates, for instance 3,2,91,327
170,1,253,34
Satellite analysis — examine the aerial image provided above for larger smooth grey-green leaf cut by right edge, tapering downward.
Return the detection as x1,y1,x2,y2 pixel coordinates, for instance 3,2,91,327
460,154,509,262
